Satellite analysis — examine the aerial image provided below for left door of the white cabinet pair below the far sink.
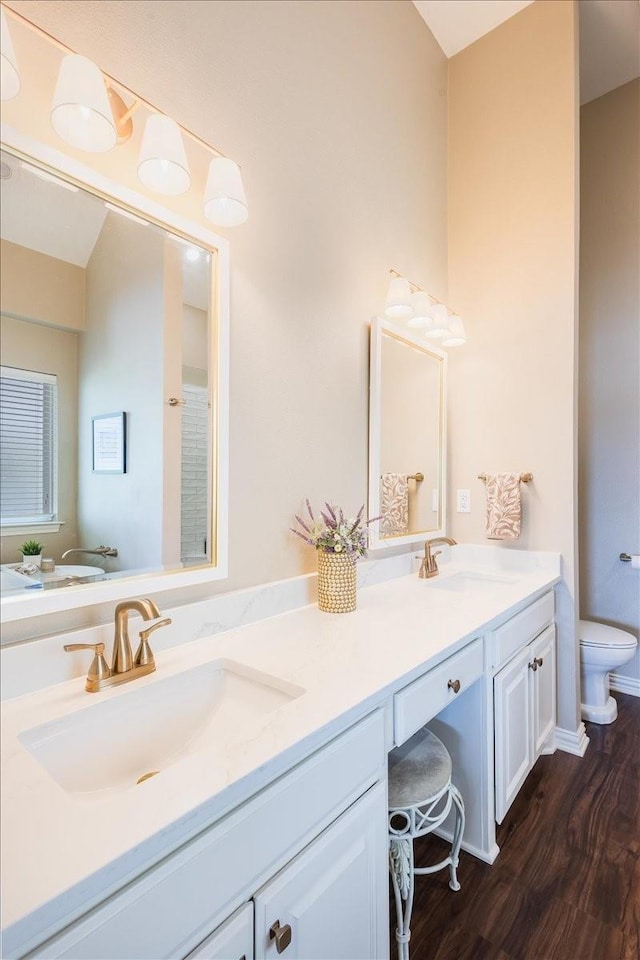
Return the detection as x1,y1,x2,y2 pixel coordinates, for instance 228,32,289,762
493,647,533,823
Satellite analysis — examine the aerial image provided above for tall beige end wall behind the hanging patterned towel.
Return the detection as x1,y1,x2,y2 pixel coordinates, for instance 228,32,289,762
449,0,579,732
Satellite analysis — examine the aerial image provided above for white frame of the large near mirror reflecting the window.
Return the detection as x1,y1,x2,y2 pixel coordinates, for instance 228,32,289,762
0,123,230,623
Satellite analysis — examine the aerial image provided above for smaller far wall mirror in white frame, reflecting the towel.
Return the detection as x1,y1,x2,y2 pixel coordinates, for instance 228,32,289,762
369,317,447,549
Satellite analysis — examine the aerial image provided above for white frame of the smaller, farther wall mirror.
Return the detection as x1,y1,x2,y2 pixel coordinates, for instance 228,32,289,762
368,317,447,550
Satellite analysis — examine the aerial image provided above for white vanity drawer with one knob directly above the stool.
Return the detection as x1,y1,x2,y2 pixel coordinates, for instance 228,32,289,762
393,639,483,747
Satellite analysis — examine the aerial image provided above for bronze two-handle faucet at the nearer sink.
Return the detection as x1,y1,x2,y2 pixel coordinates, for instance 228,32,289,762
64,599,171,693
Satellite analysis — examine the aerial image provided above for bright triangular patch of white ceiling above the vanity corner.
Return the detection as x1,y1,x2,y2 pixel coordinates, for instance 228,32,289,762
413,0,533,57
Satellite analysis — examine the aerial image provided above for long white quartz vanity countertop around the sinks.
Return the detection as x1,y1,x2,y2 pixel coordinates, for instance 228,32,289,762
1,551,560,956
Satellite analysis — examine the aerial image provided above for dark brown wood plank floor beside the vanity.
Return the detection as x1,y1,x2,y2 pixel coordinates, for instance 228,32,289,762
391,694,640,960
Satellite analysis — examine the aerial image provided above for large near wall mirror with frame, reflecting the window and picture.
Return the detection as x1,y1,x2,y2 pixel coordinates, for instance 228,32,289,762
0,143,228,620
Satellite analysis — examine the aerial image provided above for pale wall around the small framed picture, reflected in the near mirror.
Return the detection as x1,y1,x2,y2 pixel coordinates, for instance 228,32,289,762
78,213,166,571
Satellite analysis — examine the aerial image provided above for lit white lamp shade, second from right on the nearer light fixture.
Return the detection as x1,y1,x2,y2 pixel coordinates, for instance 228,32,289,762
138,113,191,197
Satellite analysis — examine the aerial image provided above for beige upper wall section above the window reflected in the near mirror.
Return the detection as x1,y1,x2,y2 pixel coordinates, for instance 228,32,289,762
0,240,84,330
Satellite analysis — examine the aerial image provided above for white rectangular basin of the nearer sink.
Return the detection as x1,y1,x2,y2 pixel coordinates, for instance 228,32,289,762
19,659,305,794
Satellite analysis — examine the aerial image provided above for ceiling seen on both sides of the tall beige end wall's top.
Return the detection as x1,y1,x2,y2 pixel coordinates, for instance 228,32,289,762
413,0,640,103
